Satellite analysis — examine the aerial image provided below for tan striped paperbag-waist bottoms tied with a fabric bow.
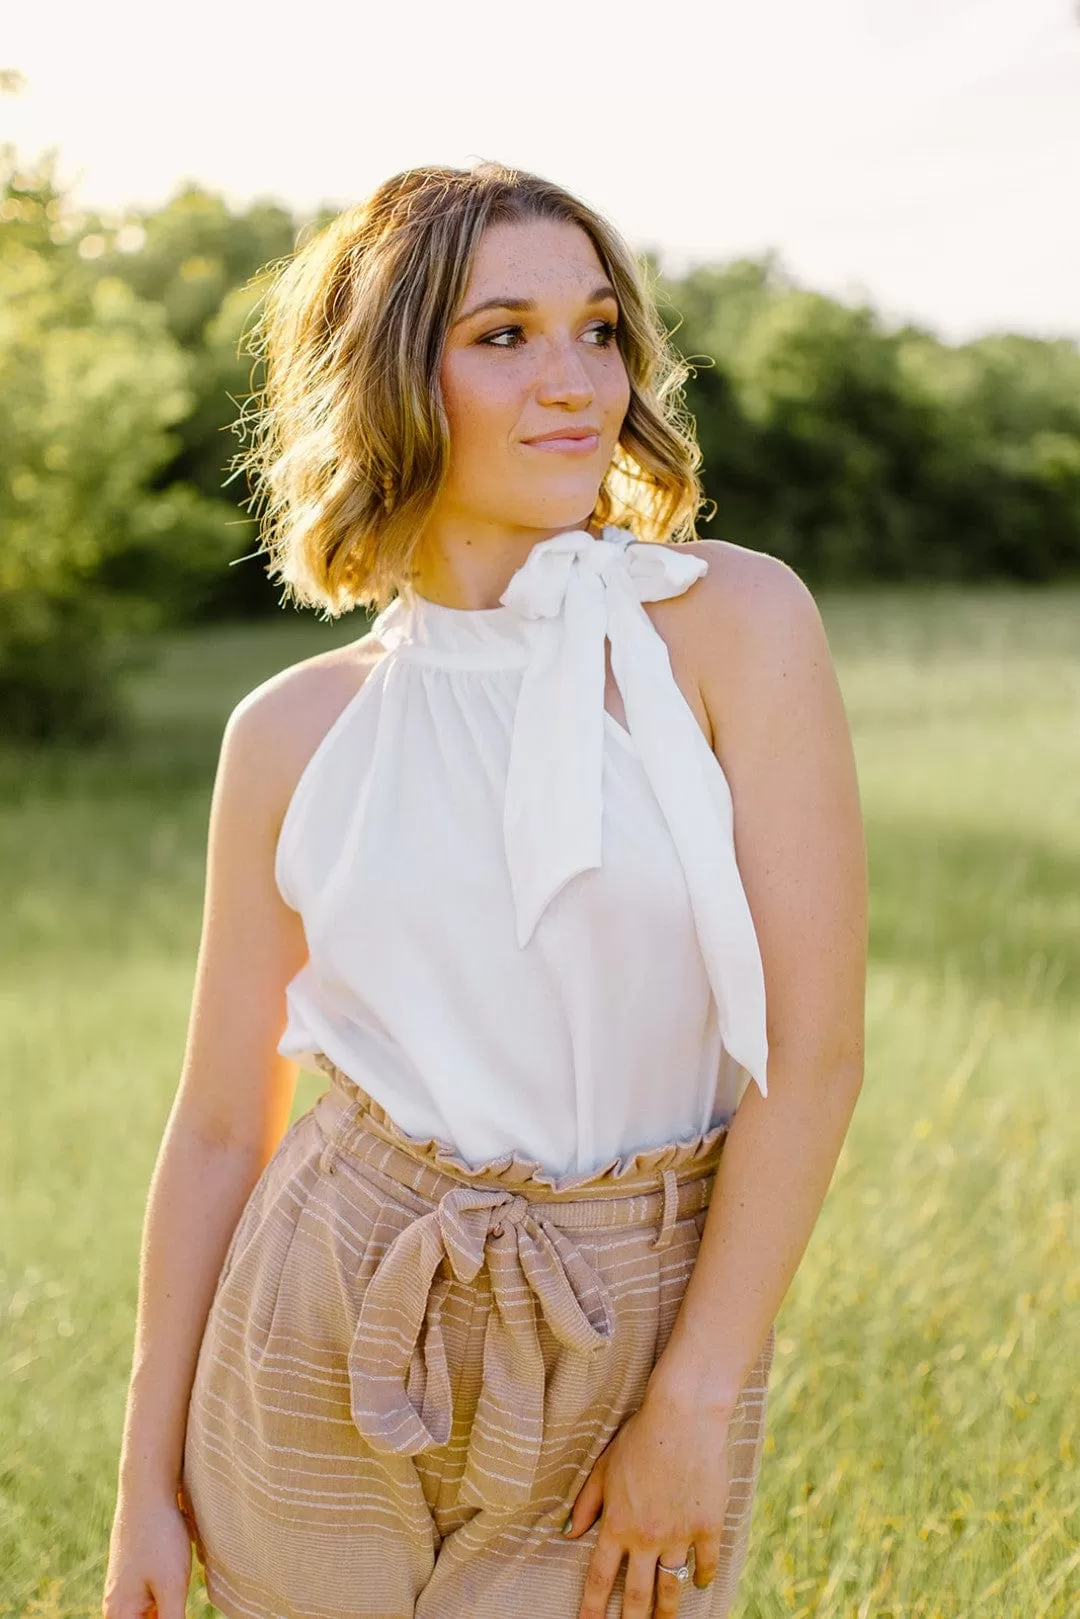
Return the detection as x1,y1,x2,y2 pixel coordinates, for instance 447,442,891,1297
183,1062,774,1619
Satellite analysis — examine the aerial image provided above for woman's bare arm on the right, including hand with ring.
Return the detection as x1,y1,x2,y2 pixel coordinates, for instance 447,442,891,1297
550,541,866,1619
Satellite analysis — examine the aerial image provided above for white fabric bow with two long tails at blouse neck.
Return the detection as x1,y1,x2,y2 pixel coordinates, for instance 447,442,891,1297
500,526,767,1096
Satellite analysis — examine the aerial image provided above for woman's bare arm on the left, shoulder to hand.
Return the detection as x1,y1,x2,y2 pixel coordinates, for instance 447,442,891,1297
104,643,380,1619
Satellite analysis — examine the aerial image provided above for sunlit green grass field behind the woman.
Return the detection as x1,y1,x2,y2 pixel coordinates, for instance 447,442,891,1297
0,588,1080,1619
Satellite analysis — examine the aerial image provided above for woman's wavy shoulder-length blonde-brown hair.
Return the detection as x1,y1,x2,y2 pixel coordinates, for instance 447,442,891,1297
230,160,703,617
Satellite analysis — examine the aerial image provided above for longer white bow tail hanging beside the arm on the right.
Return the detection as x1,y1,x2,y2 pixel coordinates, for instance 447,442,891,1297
612,593,767,1096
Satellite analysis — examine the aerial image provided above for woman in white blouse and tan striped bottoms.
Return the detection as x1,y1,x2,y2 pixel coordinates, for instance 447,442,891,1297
104,154,866,1619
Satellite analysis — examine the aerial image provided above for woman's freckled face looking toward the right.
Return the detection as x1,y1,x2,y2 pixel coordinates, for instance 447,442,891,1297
436,219,630,533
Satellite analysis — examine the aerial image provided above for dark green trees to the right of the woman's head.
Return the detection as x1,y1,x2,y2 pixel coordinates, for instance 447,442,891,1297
669,256,1080,583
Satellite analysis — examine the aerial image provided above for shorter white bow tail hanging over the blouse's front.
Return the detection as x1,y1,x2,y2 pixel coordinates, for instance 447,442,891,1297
504,580,606,949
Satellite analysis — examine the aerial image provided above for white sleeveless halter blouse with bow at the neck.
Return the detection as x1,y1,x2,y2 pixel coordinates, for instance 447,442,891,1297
275,526,767,1175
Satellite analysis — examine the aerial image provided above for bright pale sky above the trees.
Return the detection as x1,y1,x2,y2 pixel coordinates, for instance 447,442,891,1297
0,0,1080,342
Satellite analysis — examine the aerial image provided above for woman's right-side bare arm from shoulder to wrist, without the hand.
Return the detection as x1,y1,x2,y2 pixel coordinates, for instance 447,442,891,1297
649,541,868,1418
